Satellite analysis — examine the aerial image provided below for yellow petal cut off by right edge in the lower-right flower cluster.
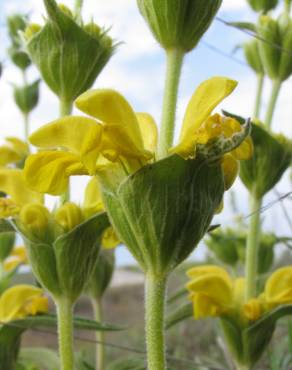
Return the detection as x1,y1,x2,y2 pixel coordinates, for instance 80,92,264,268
264,266,292,305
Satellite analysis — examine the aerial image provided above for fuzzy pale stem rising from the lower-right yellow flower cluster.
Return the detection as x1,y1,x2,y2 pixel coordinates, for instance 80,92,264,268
245,194,262,300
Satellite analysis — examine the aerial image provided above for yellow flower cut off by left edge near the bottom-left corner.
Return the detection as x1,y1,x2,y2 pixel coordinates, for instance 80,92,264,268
0,285,48,323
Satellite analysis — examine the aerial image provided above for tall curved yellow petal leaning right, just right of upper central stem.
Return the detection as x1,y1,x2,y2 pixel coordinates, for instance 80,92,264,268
171,77,237,158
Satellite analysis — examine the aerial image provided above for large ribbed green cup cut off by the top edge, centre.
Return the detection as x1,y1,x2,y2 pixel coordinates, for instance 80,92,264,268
137,0,222,52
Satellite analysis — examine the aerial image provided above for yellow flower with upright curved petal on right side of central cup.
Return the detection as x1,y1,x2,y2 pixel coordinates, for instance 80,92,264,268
170,77,253,190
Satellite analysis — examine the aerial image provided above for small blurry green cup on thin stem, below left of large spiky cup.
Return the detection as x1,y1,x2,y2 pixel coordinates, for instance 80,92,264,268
14,80,40,114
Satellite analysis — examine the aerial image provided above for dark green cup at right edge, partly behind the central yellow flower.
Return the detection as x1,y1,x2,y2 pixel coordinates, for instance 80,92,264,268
240,124,292,198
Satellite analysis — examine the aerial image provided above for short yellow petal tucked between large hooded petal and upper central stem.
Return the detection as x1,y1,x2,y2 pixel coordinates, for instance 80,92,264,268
136,113,158,153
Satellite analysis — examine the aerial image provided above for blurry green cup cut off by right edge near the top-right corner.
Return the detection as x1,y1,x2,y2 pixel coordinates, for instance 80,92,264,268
257,14,292,81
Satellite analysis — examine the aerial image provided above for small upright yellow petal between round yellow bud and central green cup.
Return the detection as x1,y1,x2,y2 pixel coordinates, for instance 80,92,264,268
82,177,104,218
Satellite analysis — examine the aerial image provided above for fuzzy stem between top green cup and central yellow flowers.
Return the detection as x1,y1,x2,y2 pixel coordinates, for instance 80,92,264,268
157,49,185,158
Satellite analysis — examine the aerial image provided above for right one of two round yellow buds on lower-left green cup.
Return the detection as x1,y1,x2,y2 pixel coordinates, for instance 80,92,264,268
55,202,83,231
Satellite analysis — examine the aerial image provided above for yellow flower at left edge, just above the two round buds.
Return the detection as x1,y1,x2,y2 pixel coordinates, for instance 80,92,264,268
0,168,43,218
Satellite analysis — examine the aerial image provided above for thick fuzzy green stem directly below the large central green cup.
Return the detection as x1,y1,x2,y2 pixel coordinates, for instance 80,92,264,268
145,273,167,370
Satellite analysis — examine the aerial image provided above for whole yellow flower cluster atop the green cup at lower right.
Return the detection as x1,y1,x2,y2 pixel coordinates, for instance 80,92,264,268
187,265,292,322
